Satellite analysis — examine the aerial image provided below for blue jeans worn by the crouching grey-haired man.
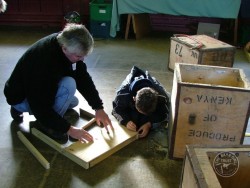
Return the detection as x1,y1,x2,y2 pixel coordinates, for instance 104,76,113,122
13,77,79,117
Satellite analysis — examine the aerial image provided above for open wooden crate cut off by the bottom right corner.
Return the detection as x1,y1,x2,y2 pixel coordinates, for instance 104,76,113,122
180,145,250,188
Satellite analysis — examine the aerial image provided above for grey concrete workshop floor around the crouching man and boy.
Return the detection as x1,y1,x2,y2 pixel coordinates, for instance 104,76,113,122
0,28,250,188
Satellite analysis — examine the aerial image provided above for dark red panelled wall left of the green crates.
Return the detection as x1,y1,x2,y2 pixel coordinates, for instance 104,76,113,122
0,0,89,28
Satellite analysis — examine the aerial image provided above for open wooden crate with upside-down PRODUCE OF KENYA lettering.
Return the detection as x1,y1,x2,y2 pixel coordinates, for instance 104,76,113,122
169,63,250,158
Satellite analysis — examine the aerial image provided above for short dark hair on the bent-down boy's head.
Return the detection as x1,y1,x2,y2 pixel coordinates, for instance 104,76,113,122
135,87,158,115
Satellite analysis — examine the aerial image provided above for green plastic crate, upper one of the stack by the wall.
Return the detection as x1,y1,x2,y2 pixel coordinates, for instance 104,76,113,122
90,0,113,21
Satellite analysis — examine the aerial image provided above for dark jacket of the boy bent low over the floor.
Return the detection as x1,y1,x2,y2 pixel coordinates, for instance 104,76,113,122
112,66,170,128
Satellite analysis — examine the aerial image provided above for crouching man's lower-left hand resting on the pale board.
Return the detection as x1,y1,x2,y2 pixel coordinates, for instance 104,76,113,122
67,126,93,143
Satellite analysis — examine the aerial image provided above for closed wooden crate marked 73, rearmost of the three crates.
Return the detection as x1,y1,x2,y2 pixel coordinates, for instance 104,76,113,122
168,35,236,71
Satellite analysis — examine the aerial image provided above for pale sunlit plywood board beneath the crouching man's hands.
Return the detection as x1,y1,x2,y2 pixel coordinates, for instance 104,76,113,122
64,122,137,168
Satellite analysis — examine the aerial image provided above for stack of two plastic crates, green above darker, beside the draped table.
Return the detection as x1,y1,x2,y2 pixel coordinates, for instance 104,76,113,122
90,0,112,38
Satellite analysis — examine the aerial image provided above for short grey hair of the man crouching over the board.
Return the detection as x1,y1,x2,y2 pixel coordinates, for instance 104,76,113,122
57,23,94,55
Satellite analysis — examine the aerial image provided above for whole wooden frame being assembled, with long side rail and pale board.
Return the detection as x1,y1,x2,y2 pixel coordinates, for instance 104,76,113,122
31,109,138,169
